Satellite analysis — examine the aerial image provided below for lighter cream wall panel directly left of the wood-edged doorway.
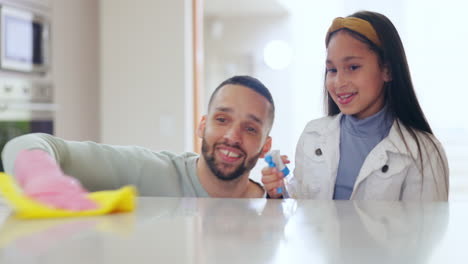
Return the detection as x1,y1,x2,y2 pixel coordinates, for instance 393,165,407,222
99,0,193,152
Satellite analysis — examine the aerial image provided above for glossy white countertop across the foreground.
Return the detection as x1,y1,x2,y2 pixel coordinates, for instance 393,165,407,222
0,198,468,264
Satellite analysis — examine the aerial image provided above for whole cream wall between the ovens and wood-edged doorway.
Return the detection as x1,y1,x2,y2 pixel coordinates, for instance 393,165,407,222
51,0,193,152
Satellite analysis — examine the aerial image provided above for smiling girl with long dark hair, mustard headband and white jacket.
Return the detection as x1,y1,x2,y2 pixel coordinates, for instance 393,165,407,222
262,11,449,201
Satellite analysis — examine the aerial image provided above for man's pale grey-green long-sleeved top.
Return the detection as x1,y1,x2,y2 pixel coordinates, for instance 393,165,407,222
2,133,209,197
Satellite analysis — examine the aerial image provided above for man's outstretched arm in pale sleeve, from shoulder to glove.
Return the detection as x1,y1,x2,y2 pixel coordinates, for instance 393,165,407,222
2,134,159,191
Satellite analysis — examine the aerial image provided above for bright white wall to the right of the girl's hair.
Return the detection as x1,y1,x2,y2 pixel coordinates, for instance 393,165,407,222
403,0,468,201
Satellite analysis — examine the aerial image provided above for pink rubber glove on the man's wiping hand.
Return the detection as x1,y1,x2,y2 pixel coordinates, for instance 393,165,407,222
15,149,97,211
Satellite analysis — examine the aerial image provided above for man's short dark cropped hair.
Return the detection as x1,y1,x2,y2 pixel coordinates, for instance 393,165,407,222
208,75,275,124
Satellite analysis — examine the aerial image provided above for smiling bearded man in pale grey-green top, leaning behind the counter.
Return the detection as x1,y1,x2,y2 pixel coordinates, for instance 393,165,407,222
2,76,275,198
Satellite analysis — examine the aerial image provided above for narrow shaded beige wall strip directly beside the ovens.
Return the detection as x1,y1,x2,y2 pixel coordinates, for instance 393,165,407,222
51,0,100,141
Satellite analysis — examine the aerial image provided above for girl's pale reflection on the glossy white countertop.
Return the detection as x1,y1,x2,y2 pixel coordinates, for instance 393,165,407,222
272,200,449,264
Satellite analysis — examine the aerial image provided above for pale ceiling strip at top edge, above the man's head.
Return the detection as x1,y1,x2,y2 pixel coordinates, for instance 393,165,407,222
203,0,287,17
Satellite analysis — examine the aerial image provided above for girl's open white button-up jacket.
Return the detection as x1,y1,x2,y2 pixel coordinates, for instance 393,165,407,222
286,114,449,201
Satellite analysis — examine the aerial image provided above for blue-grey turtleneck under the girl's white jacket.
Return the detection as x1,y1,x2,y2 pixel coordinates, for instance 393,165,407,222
333,107,393,200
